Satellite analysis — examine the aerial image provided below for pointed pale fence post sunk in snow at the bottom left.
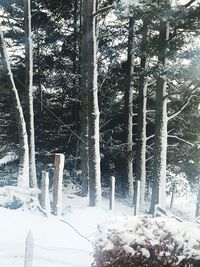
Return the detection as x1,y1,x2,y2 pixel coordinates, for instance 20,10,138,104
24,231,34,267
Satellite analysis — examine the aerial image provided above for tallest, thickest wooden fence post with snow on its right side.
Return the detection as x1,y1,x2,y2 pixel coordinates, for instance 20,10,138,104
53,154,65,216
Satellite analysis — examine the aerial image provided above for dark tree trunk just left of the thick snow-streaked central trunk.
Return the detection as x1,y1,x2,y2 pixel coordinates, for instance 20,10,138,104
80,0,89,197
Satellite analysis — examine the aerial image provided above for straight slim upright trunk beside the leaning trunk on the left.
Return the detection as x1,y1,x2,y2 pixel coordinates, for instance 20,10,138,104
24,0,38,188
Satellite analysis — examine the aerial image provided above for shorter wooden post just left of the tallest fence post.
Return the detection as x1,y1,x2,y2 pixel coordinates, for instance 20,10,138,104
40,171,51,213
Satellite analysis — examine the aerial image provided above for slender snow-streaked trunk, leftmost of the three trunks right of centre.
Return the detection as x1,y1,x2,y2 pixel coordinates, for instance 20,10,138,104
125,18,135,200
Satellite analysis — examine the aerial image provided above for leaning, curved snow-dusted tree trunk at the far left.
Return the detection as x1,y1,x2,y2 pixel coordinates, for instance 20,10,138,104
0,29,29,188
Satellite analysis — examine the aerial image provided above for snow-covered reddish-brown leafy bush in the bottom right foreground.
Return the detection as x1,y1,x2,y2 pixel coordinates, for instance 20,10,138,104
93,217,200,267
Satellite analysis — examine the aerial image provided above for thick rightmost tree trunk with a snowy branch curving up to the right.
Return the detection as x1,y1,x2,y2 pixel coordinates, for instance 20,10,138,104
150,0,198,213
